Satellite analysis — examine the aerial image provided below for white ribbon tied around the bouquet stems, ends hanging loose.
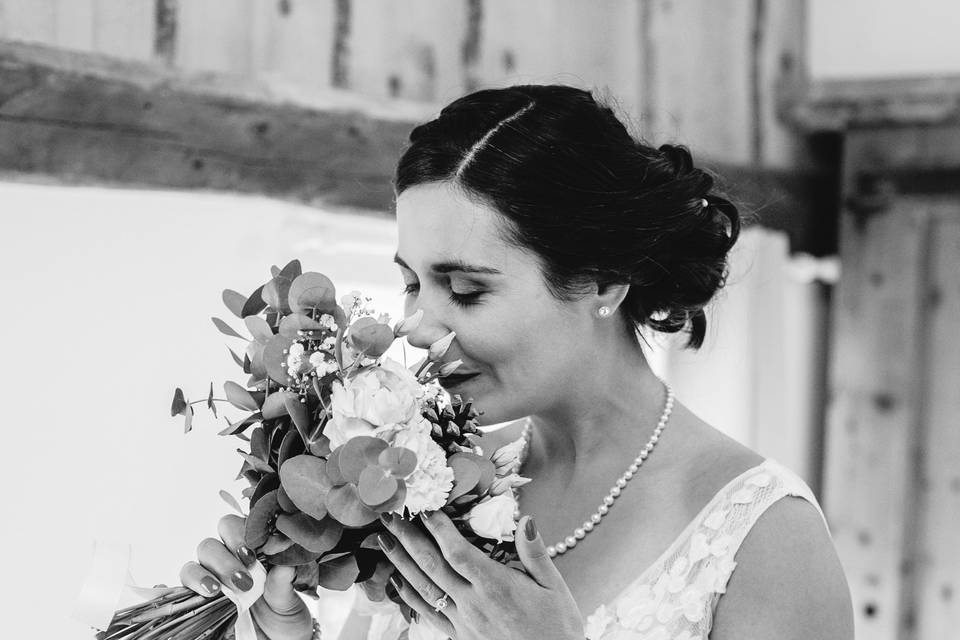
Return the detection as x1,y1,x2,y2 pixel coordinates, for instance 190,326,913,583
73,542,267,640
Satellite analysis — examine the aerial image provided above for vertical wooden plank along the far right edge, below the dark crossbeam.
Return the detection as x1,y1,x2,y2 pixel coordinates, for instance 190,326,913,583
916,205,960,639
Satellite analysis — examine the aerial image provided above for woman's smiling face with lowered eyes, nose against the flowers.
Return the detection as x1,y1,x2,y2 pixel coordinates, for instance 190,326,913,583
396,183,592,424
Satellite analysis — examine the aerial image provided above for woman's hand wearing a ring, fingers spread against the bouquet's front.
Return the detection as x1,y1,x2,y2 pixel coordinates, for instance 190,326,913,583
380,511,584,640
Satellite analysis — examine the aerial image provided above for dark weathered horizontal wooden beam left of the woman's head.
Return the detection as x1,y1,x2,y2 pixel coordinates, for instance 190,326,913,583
0,43,423,210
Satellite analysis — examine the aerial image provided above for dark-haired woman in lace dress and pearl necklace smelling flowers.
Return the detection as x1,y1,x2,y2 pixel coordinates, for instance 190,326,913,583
183,86,853,640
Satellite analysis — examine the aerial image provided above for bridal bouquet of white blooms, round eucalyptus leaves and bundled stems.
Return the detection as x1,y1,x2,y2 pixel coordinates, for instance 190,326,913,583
97,260,528,640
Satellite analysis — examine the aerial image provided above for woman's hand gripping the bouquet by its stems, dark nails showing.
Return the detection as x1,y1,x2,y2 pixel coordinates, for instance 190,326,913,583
180,515,313,640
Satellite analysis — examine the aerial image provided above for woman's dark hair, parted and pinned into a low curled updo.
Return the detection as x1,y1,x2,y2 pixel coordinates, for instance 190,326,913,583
395,85,740,348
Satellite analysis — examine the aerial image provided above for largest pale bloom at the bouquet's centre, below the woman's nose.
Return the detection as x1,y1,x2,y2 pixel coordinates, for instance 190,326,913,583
324,359,421,448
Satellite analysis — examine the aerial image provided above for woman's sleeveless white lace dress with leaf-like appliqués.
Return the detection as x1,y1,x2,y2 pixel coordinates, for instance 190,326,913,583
356,459,826,640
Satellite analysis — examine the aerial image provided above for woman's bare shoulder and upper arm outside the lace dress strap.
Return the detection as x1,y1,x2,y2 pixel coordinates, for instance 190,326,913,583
710,496,853,640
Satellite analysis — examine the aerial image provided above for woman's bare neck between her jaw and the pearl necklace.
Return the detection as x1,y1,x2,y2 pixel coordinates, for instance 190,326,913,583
523,336,666,486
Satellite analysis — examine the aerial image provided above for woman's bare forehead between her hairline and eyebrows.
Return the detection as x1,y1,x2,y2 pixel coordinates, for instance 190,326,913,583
396,183,522,270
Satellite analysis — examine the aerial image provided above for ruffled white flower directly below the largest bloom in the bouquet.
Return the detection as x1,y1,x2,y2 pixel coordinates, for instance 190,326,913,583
390,416,454,514
